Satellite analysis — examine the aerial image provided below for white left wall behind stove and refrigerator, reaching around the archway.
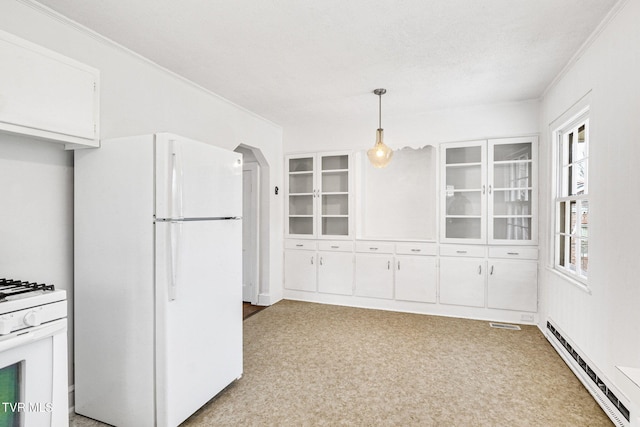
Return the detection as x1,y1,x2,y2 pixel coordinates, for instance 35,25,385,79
0,0,283,394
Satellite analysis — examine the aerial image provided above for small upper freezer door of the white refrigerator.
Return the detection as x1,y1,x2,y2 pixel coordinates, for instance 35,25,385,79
155,133,242,219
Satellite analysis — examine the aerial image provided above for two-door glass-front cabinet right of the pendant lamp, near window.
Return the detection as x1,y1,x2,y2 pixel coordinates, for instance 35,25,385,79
440,137,537,245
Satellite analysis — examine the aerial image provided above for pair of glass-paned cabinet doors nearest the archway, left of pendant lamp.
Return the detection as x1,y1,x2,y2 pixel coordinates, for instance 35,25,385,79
286,152,352,239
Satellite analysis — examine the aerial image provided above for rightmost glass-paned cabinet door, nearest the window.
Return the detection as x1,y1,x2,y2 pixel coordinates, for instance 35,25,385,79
487,137,538,245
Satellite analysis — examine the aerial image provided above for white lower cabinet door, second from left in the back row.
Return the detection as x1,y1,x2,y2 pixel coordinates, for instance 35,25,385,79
318,252,353,295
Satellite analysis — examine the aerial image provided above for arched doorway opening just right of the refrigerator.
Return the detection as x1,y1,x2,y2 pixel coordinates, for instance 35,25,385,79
234,144,269,305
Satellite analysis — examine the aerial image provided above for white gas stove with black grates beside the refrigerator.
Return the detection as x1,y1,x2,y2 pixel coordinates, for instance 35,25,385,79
0,279,69,427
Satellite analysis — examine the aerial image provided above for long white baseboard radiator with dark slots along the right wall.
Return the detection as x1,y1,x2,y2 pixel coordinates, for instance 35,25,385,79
546,321,631,427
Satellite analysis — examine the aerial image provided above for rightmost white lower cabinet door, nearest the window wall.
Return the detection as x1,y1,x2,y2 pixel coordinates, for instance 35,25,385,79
487,260,538,312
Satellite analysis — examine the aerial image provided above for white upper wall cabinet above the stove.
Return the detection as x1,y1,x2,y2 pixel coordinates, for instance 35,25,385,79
0,31,100,148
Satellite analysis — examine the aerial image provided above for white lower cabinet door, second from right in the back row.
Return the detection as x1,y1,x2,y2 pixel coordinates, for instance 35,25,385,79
440,257,486,307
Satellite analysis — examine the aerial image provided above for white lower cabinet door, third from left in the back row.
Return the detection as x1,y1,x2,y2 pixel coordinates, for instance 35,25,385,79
355,254,393,299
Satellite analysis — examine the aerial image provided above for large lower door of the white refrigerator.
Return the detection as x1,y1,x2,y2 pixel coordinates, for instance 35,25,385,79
156,220,242,426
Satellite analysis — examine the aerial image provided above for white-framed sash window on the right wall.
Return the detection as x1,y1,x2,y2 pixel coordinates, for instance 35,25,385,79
551,105,591,289
